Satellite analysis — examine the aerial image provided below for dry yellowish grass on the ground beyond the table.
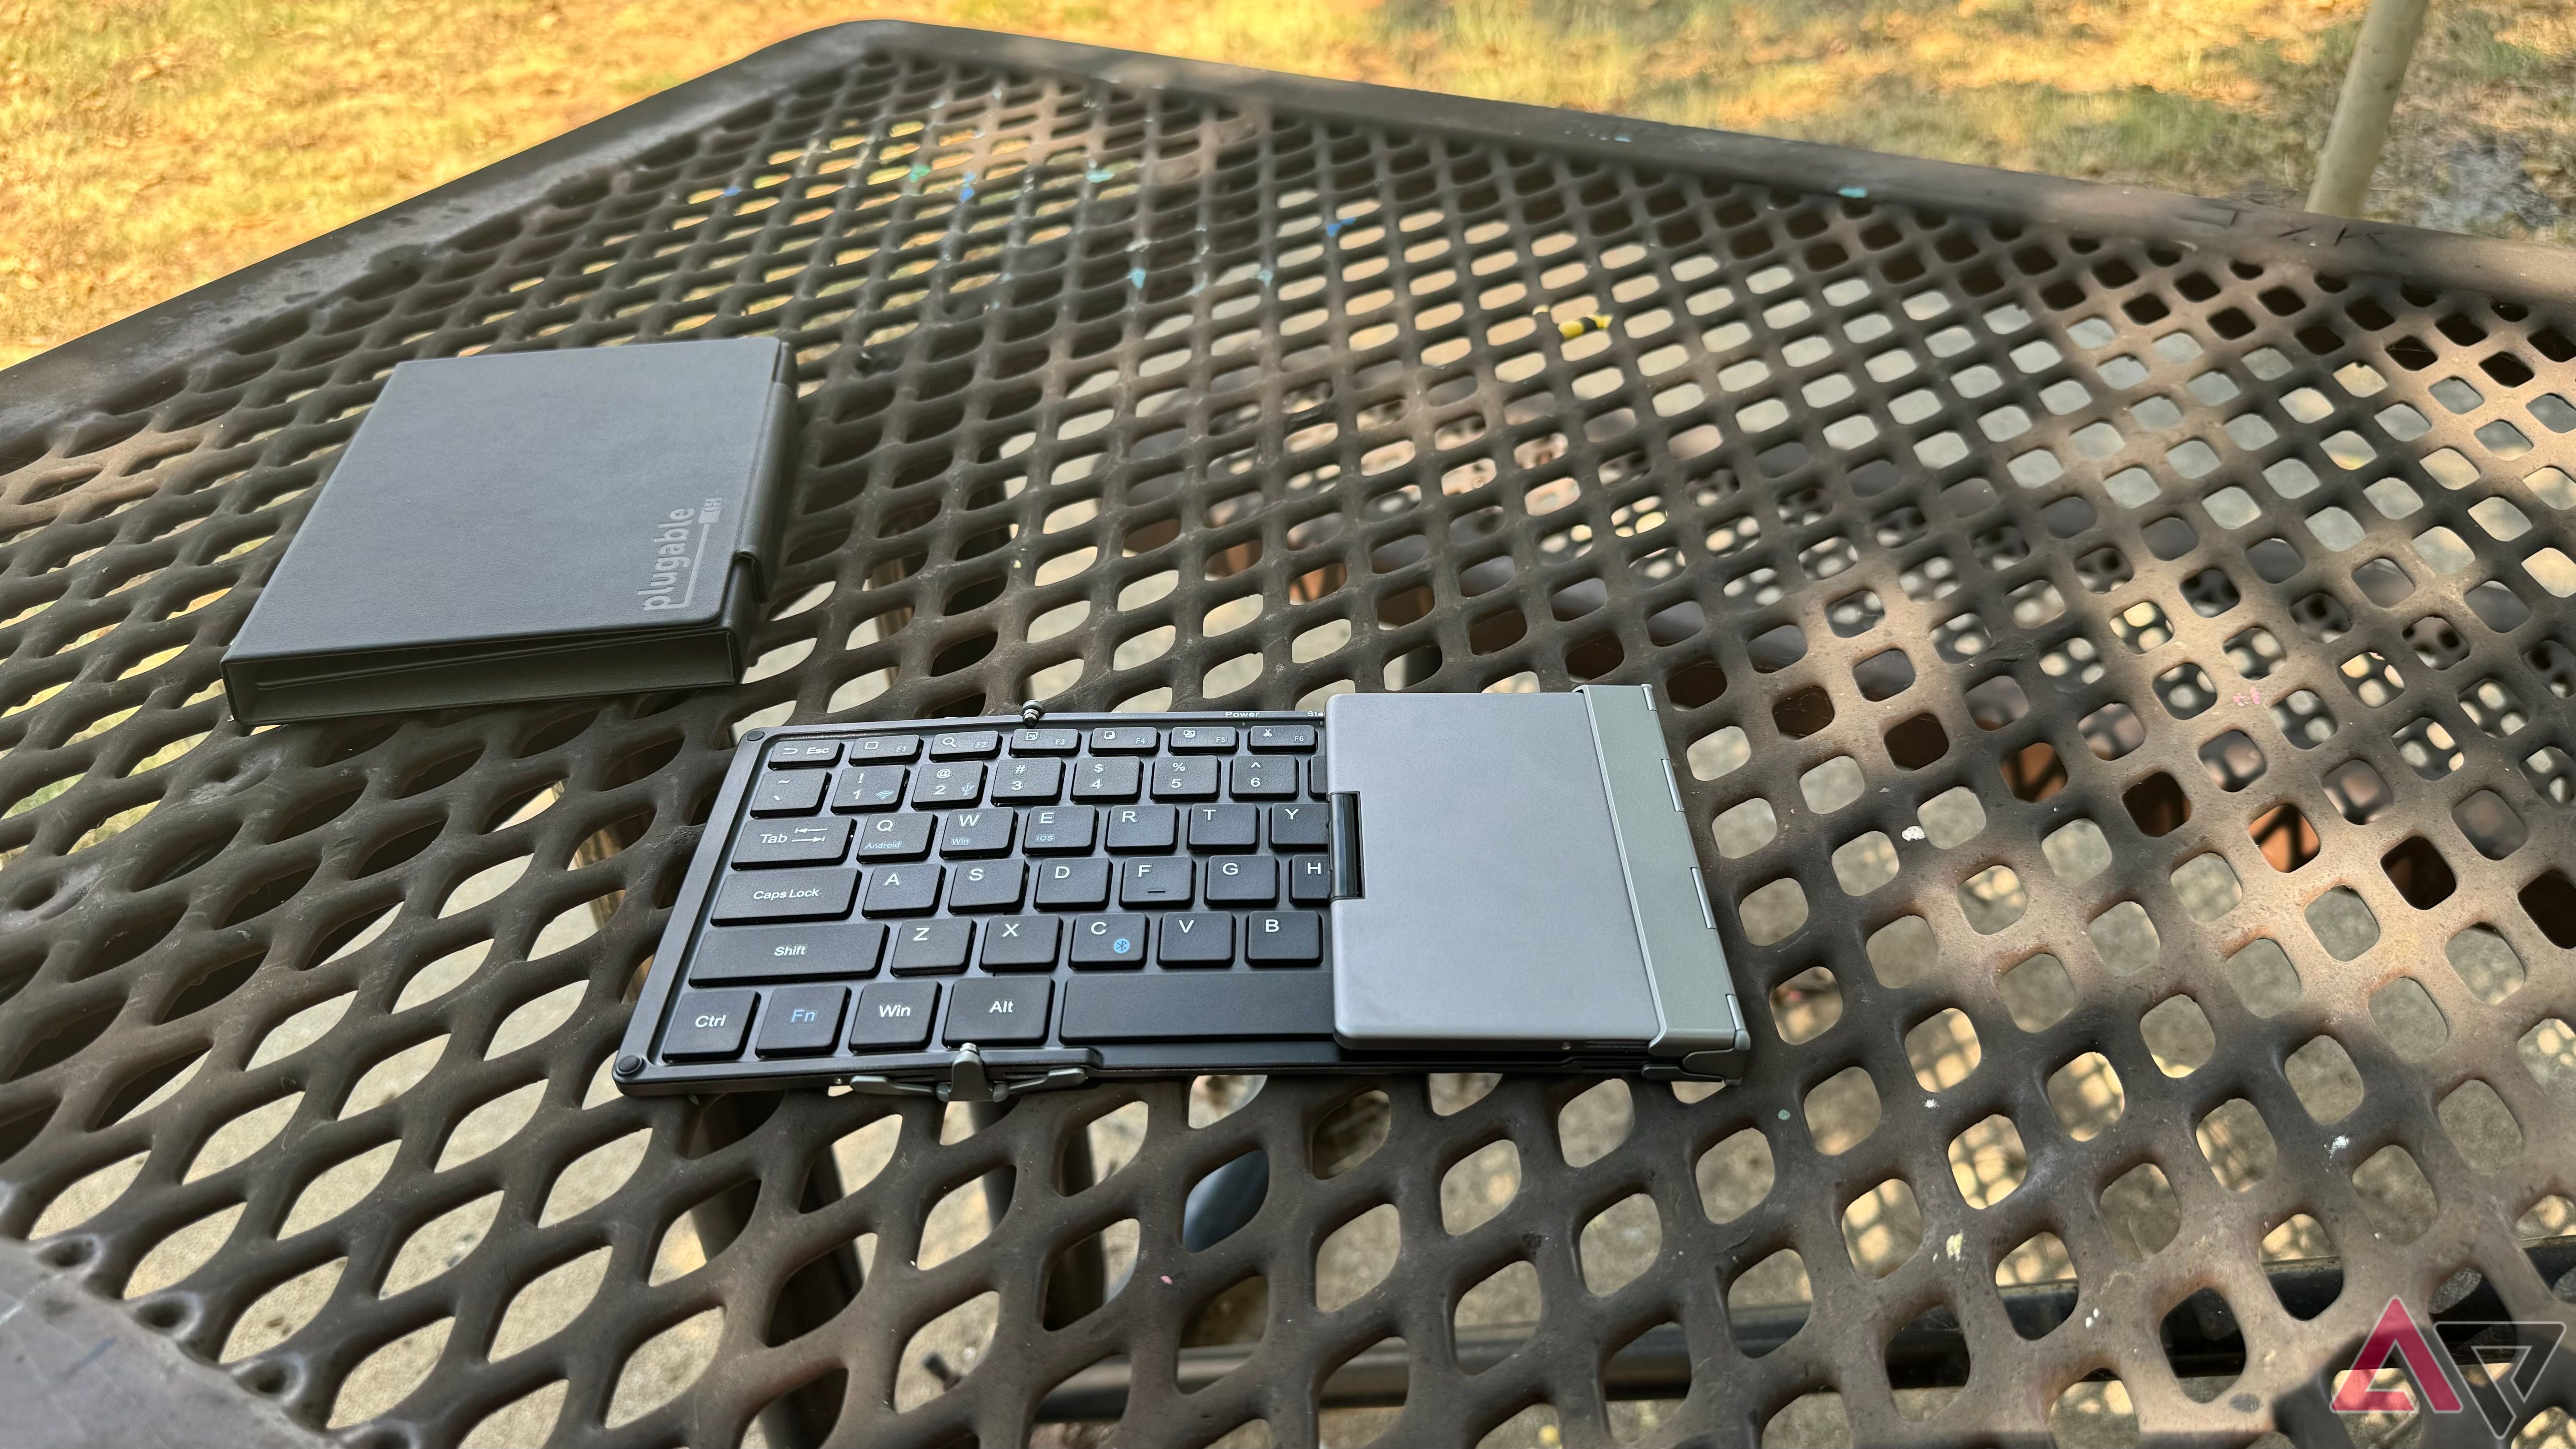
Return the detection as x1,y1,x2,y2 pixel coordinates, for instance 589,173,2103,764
0,0,2576,363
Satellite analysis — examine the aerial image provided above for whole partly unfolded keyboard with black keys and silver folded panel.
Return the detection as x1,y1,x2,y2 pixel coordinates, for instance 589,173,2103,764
618,688,1747,1098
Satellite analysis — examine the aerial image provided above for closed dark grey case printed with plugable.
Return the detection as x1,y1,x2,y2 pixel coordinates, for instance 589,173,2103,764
224,338,796,725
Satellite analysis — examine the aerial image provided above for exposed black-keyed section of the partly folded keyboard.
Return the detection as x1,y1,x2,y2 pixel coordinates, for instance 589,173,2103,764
618,714,1339,1090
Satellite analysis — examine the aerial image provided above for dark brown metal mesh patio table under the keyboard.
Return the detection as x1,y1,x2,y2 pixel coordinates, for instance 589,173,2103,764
0,26,2576,1444
